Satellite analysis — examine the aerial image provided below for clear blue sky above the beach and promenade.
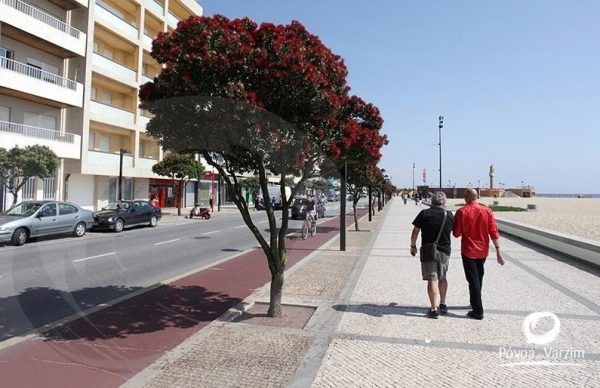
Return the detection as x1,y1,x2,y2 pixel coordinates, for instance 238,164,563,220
199,0,600,194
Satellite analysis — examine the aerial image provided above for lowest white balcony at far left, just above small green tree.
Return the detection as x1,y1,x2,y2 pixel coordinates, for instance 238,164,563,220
0,121,81,159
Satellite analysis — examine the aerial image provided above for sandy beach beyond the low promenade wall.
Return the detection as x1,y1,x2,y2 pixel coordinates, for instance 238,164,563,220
448,197,600,241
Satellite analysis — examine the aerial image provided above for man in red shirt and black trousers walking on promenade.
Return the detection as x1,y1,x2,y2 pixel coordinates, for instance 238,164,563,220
452,189,504,320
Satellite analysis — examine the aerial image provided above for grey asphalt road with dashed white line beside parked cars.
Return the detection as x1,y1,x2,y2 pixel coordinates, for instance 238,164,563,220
0,202,351,342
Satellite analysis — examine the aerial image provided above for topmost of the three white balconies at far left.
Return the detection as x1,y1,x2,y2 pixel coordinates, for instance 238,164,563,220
0,0,87,57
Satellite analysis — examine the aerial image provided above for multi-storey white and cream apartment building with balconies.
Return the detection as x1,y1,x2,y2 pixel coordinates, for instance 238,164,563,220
0,0,202,209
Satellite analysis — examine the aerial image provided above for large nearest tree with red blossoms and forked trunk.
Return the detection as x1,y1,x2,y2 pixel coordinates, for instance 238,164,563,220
140,15,382,316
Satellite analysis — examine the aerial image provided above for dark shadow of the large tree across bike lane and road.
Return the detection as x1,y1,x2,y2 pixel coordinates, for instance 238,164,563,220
0,285,240,341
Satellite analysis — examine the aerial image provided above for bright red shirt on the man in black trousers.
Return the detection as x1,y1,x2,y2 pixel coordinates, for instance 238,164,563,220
452,201,500,259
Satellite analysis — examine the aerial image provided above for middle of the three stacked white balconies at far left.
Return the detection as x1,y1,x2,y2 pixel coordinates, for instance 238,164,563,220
0,57,83,108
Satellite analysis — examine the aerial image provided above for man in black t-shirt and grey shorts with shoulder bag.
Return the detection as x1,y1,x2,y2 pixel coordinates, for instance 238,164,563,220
410,191,454,319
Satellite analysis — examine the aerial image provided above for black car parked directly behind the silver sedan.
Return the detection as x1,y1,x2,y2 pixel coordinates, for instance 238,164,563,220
94,201,162,233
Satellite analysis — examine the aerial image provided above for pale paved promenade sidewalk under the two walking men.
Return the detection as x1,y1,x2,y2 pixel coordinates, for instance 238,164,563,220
126,200,600,387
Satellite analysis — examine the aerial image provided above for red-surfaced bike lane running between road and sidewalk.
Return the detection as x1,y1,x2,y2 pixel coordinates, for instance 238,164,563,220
0,209,367,387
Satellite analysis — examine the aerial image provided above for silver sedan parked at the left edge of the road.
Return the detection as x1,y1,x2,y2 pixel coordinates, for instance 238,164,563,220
0,201,94,245
